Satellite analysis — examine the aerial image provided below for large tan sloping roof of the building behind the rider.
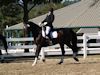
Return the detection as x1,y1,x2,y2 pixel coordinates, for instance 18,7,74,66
6,0,100,30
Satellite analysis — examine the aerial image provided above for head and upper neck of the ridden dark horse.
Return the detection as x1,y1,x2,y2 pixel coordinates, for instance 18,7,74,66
27,21,41,36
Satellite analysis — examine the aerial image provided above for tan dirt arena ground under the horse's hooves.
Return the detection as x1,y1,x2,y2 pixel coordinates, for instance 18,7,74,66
0,55,100,75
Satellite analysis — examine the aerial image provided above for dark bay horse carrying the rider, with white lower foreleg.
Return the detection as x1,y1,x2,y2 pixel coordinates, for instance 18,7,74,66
27,22,79,66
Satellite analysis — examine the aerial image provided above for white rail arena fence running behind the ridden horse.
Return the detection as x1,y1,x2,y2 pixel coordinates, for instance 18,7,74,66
0,33,100,58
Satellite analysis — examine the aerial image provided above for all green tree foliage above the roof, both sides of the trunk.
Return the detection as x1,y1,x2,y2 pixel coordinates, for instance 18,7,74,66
0,0,64,31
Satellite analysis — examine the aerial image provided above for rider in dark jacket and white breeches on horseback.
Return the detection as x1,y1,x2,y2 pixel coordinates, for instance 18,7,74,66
41,8,55,44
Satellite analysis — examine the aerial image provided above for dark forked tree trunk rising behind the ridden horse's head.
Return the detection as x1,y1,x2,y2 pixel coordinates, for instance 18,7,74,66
18,0,43,52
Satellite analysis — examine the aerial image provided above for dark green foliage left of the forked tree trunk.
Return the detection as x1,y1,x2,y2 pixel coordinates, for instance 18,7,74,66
0,3,22,32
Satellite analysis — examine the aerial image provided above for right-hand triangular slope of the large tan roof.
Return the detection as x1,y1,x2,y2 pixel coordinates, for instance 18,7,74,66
70,0,100,27
